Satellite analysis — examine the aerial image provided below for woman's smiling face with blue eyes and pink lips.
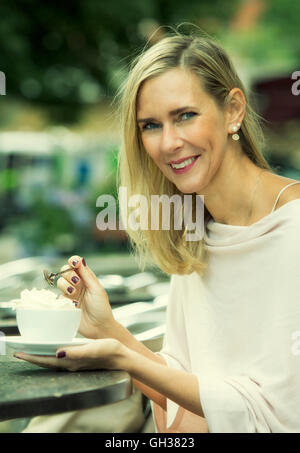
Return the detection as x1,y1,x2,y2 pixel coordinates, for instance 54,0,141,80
137,68,229,194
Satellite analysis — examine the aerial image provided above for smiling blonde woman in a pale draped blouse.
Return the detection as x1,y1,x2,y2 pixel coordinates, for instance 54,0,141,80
18,35,300,432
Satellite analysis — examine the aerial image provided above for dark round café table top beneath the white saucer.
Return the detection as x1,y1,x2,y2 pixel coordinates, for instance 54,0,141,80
0,353,132,421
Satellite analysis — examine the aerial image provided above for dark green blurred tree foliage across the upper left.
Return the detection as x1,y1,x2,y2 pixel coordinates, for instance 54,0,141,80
0,0,239,122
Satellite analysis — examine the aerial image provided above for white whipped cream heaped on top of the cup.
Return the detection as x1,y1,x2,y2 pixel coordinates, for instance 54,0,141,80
15,288,76,310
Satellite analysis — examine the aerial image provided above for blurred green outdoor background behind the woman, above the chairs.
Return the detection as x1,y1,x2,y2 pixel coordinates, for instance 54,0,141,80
0,0,300,263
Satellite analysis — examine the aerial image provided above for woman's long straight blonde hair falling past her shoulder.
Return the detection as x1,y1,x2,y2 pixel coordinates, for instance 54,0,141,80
118,33,270,275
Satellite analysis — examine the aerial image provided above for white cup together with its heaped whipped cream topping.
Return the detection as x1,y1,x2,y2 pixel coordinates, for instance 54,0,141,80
16,288,81,342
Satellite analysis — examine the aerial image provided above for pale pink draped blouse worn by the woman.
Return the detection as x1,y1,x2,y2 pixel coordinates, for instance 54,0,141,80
151,182,300,433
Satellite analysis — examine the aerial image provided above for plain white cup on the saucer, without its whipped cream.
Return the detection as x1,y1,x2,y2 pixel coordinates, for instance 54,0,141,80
16,308,81,342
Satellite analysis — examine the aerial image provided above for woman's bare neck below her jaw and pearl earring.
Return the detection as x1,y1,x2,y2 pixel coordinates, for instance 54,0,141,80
202,148,263,226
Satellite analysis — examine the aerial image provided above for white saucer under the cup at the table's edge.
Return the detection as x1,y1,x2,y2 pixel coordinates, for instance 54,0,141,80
0,335,93,355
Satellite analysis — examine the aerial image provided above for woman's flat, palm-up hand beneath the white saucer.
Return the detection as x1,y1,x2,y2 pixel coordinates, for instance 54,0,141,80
14,338,127,371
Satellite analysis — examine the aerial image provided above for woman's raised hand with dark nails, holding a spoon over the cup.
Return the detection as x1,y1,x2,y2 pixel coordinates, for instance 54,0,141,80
57,255,115,338
